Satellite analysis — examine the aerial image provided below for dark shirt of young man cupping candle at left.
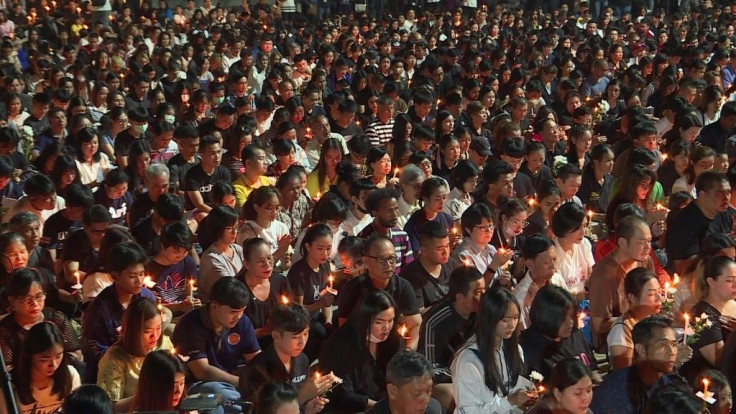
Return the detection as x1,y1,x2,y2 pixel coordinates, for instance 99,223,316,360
82,283,156,384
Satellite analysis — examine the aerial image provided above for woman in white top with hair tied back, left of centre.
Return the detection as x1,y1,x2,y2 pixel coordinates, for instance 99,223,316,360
236,186,291,270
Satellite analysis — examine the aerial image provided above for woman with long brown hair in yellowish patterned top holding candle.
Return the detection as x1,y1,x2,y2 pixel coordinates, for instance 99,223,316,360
97,297,173,412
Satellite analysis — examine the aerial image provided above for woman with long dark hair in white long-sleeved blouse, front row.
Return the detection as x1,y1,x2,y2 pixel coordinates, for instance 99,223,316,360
450,288,532,414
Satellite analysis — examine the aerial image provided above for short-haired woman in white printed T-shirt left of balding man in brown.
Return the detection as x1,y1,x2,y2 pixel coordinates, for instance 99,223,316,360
552,203,595,300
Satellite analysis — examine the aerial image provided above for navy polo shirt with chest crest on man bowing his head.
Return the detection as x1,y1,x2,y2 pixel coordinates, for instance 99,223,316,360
172,305,261,373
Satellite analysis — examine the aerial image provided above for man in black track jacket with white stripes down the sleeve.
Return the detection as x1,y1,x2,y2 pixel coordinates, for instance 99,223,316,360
417,266,486,410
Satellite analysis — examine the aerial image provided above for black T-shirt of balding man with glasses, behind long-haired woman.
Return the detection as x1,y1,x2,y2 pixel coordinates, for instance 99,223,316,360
337,274,419,318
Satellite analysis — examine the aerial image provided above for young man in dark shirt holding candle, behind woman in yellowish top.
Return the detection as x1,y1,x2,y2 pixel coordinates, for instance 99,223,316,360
82,242,156,382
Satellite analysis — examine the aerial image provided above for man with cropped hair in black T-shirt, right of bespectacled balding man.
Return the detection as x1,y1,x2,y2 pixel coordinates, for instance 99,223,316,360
401,221,451,311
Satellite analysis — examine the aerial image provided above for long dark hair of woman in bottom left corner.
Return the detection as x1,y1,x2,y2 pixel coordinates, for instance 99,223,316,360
15,322,72,405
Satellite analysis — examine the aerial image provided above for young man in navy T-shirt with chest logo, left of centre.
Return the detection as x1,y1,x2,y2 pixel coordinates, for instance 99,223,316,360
146,220,202,315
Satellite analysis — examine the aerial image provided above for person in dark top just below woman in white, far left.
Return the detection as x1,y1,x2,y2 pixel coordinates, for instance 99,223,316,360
41,183,95,261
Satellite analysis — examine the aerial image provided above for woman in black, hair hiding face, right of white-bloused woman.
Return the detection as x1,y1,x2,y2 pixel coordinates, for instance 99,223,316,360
519,285,596,378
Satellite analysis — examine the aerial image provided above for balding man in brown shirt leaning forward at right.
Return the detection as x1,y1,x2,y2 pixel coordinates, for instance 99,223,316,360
588,215,655,348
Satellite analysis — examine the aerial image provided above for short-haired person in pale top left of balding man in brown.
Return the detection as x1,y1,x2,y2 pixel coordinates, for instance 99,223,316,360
514,234,567,329
